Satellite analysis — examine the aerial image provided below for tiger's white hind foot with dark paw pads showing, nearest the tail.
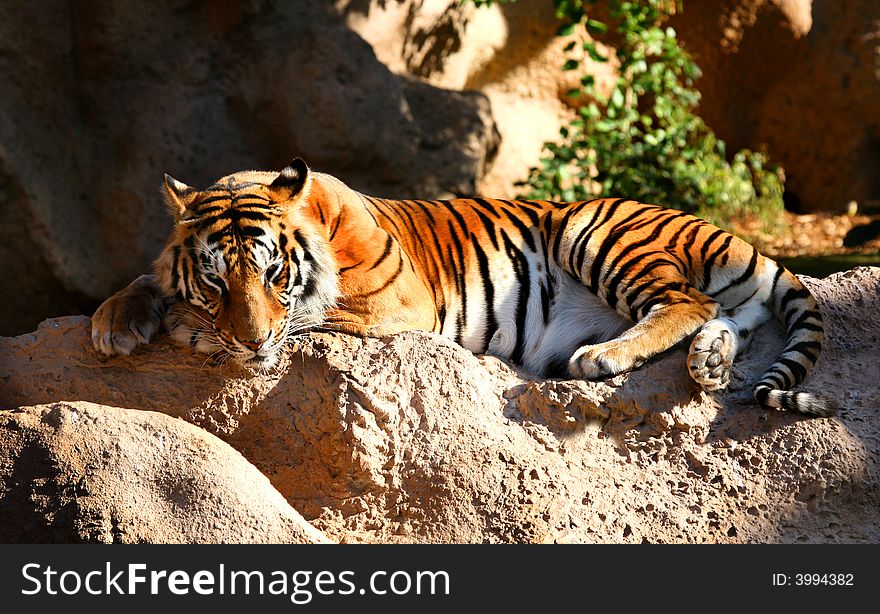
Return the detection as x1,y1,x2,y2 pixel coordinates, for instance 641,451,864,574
687,301,772,390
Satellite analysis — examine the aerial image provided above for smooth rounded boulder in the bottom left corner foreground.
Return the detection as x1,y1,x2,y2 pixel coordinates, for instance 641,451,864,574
0,401,328,543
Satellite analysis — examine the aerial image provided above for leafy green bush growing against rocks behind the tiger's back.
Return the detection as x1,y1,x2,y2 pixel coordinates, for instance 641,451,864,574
474,0,783,231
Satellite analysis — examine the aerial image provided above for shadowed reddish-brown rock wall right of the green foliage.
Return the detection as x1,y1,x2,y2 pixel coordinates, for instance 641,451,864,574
672,0,880,212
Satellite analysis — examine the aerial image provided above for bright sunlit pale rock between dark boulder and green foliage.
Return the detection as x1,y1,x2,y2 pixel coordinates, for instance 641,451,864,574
337,0,616,198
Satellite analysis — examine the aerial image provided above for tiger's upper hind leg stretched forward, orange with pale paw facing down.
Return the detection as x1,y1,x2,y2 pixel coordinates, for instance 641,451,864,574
568,284,719,379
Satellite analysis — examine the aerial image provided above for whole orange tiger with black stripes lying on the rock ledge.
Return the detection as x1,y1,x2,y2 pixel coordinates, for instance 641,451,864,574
92,158,836,416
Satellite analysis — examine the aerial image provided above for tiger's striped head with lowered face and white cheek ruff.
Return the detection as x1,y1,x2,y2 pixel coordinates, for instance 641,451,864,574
155,158,339,370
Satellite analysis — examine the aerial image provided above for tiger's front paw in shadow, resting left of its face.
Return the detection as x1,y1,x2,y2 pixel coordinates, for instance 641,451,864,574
92,275,165,356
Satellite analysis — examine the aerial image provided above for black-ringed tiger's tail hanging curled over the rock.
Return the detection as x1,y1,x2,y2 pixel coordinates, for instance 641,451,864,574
754,265,837,417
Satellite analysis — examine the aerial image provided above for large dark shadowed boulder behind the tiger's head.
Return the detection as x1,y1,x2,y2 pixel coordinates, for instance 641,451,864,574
0,0,498,335
